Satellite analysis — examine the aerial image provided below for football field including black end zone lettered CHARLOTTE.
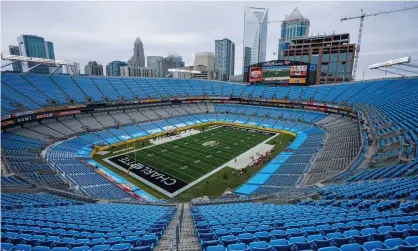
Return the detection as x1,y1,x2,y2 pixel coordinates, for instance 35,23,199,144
106,126,275,193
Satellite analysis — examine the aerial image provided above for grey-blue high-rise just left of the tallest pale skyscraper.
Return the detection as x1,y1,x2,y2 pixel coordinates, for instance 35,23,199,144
215,38,235,81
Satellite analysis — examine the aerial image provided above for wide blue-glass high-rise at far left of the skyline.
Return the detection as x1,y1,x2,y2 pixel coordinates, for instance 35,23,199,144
17,35,56,74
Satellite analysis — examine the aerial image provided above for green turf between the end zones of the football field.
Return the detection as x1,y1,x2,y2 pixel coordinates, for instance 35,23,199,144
112,127,272,182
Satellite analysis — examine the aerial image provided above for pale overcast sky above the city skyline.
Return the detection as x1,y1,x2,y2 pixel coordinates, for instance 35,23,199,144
1,1,418,79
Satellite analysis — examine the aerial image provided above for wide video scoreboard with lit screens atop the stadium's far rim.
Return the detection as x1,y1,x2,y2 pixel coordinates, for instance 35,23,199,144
244,60,316,85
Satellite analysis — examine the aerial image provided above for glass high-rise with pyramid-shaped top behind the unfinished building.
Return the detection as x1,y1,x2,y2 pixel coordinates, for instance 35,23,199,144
277,8,310,60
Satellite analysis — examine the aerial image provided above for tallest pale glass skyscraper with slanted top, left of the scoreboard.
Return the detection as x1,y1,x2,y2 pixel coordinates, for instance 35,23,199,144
243,6,268,71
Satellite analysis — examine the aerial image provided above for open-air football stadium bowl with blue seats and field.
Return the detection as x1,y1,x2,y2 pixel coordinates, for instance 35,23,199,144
1,69,418,251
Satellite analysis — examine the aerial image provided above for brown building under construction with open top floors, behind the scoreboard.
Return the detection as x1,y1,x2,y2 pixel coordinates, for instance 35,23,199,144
284,33,356,84
